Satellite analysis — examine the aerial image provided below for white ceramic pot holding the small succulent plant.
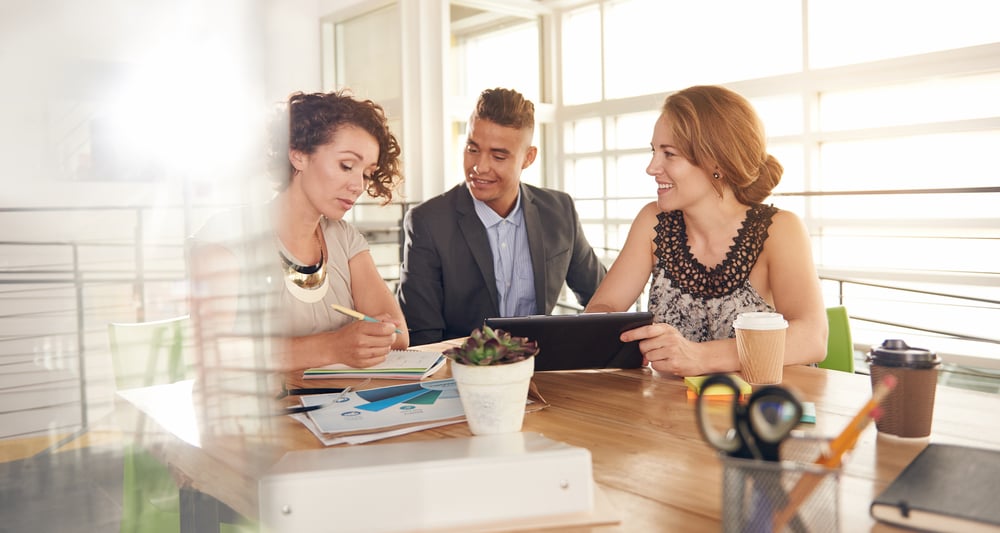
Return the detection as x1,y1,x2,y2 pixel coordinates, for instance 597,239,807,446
451,357,535,435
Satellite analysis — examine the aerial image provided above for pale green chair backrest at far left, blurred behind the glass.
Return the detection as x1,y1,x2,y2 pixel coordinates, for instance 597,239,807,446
108,315,193,389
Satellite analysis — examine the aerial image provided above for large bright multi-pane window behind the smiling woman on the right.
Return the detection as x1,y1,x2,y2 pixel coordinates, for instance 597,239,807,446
554,0,1000,360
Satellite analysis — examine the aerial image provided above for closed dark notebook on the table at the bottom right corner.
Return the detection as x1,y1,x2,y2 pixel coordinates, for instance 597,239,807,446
871,443,1000,531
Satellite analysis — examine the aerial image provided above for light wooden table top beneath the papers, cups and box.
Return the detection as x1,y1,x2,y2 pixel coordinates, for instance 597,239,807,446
119,345,1000,531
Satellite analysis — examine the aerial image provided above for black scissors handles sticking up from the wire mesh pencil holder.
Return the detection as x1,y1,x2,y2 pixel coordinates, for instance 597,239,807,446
697,374,802,461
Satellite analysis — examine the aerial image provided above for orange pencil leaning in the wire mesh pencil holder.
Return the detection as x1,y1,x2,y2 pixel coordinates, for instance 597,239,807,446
772,375,896,531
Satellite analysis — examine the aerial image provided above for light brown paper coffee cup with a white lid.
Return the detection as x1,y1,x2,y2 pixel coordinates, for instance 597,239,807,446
733,313,788,385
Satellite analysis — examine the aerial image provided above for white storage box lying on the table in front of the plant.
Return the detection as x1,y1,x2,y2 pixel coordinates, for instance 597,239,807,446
260,433,595,533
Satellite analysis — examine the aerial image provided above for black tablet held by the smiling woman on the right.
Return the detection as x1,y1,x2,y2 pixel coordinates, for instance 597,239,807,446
485,311,653,370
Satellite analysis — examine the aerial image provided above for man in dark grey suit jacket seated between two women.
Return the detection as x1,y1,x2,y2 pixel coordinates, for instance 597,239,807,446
397,88,606,345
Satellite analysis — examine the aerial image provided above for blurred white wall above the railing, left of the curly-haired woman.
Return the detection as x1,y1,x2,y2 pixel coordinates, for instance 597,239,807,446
0,0,320,212
